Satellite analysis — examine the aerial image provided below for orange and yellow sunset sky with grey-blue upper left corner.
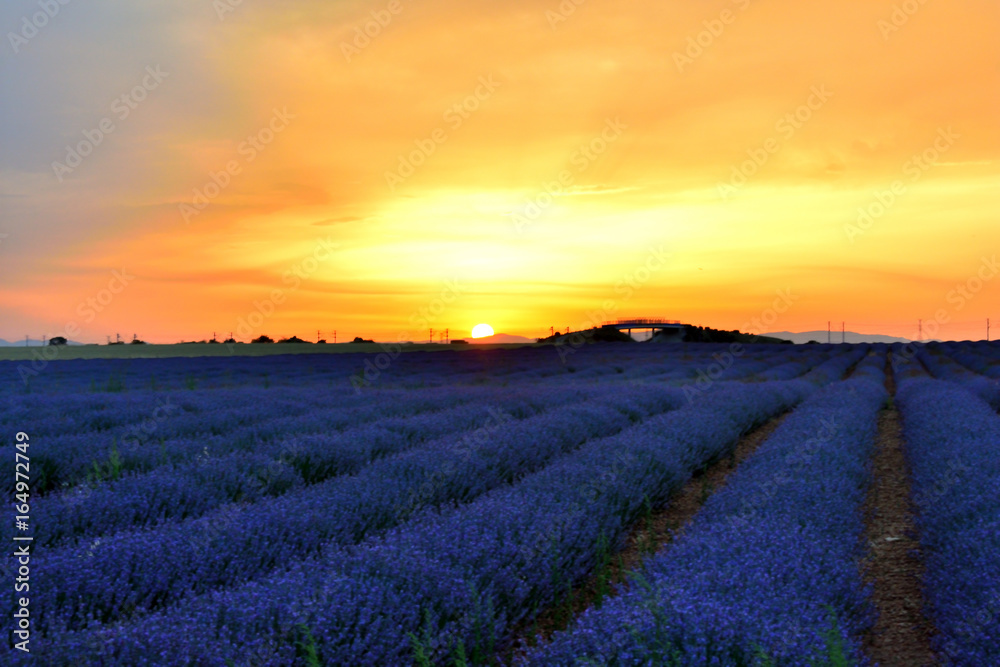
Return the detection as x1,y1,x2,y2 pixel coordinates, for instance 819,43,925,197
0,0,1000,343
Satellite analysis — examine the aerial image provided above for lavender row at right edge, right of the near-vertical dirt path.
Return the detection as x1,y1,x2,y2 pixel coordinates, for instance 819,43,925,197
897,377,1000,667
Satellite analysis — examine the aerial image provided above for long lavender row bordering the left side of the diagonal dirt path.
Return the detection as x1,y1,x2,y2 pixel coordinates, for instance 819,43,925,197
23,355,854,665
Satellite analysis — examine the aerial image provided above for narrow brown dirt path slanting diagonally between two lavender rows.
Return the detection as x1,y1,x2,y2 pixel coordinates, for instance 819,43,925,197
503,413,789,664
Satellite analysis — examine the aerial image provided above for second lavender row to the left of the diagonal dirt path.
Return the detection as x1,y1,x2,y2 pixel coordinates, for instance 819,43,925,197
27,380,682,629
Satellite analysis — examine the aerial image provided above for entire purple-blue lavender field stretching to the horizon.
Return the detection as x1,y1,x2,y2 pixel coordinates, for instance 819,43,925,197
0,343,1000,667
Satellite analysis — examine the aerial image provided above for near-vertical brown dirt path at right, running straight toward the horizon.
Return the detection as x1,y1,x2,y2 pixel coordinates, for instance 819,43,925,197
862,353,939,667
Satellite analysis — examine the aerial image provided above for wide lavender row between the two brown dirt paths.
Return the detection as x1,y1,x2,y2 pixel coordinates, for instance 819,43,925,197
524,356,887,666
